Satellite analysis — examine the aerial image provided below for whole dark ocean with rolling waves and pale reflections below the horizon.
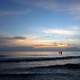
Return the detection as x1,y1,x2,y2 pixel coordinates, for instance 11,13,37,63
0,51,80,80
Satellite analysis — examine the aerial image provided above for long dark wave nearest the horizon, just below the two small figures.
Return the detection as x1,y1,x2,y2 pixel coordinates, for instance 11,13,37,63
0,56,80,62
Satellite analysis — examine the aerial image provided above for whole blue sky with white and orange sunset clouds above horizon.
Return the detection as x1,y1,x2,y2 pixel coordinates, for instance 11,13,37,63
0,0,80,50
